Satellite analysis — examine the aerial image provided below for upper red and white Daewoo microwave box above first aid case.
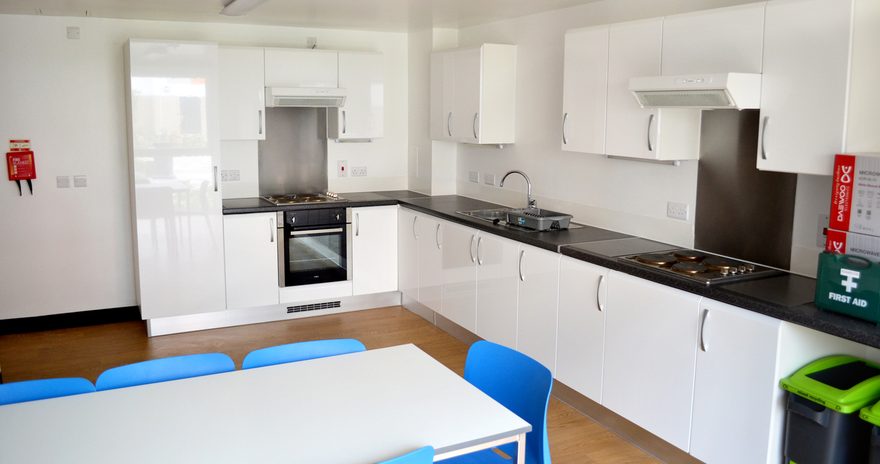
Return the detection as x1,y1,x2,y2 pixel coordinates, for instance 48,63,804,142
828,154,880,236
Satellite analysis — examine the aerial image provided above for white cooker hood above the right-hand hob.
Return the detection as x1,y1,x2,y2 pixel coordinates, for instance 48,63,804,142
629,73,761,110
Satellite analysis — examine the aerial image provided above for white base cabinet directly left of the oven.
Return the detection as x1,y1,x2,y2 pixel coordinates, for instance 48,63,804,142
223,212,283,309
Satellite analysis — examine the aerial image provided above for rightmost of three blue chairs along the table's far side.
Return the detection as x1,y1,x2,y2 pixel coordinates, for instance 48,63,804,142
241,338,367,369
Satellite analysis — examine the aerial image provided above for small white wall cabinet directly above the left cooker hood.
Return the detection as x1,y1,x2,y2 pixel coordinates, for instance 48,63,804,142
265,48,339,88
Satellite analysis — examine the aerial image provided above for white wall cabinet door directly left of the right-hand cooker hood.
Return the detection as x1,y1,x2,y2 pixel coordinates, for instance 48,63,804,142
605,18,663,158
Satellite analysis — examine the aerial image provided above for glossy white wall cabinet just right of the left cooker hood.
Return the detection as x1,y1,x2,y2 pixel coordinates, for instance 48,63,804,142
327,52,385,140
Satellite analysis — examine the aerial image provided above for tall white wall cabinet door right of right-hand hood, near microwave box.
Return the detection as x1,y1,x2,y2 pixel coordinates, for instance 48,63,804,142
758,0,852,175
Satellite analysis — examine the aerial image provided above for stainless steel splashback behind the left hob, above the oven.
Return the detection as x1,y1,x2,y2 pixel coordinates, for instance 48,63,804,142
259,108,327,195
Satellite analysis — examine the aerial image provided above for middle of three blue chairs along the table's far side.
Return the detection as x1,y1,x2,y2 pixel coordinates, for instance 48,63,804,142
95,353,235,391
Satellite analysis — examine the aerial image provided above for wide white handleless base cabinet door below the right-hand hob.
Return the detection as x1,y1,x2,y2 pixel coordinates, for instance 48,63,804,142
602,272,700,450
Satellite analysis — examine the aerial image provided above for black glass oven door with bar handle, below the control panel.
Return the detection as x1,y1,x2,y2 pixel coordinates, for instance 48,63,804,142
282,224,349,287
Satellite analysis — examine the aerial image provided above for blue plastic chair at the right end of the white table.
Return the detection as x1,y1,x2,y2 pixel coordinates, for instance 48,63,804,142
464,341,553,464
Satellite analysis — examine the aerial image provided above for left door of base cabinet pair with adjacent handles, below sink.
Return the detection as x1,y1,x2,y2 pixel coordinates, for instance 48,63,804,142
440,222,477,332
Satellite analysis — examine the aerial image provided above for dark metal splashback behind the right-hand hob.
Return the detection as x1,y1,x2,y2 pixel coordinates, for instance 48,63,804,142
694,110,797,269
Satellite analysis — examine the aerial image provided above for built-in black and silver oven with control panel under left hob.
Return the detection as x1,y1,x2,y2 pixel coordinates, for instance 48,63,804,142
277,208,351,287
